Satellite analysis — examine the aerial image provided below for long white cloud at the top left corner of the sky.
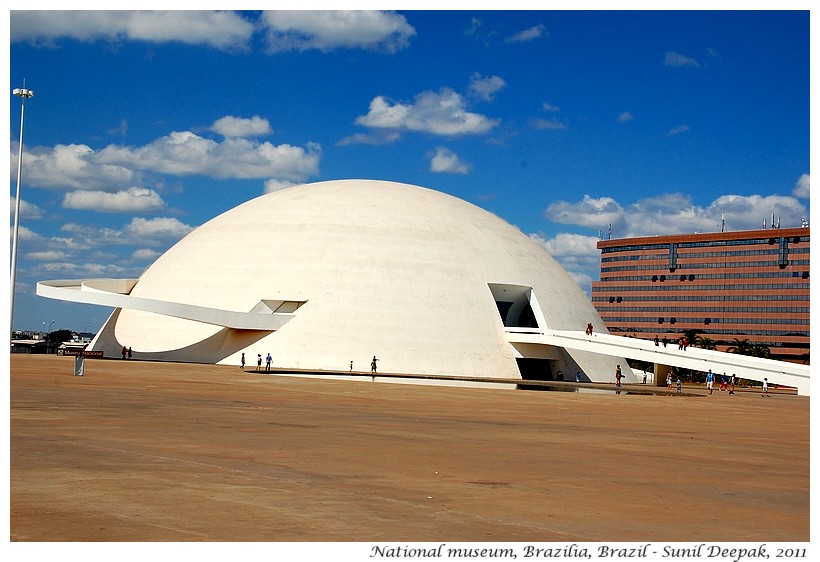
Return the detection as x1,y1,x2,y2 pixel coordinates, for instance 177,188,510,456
10,10,254,50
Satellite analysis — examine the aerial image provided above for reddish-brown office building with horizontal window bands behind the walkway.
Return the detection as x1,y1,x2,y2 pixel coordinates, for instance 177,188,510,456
592,227,810,363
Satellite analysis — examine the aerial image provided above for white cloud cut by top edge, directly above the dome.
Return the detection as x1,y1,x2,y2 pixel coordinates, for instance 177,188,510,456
262,10,416,53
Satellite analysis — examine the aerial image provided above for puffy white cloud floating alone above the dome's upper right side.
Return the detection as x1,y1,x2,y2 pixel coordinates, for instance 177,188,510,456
356,88,500,136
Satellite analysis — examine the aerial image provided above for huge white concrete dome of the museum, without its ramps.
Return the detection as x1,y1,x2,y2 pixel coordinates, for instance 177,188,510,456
92,180,632,382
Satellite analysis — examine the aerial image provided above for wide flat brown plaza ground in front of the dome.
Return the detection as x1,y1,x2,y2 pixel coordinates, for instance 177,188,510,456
9,355,810,542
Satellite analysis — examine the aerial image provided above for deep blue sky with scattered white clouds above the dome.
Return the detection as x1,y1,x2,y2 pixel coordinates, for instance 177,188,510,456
9,9,810,331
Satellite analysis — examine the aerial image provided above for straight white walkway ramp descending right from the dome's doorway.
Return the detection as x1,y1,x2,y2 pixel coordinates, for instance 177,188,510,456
506,328,810,396
